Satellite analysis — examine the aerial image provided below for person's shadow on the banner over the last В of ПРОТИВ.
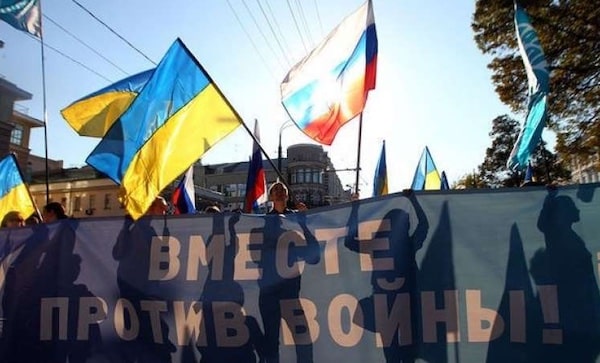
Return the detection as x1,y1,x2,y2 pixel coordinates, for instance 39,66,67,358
197,213,263,363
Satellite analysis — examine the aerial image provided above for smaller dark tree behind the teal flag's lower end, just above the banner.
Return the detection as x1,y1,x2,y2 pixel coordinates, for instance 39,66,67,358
478,115,571,188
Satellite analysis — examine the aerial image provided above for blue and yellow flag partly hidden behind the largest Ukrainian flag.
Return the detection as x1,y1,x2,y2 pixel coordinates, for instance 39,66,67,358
60,69,154,137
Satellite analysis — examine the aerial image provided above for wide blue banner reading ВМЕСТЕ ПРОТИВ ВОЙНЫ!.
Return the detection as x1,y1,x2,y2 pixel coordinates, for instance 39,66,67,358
0,184,600,363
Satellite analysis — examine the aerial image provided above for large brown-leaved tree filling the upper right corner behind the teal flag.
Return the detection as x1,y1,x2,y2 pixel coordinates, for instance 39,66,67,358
471,0,600,167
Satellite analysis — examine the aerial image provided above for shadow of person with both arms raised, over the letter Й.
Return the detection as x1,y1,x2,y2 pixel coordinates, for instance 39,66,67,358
344,190,429,363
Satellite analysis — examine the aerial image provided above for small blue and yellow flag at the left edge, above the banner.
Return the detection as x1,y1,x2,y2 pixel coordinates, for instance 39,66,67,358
0,154,37,219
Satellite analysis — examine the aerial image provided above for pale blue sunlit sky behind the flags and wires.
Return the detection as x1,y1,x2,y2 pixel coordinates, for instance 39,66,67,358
0,0,522,197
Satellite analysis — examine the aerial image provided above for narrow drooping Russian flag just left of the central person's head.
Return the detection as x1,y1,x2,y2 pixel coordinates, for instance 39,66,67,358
244,120,267,213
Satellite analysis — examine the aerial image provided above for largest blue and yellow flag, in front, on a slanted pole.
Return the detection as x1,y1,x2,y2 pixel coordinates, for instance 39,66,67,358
86,39,242,219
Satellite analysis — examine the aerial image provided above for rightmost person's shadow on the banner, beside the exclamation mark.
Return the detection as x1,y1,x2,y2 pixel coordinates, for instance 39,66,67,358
532,187,600,363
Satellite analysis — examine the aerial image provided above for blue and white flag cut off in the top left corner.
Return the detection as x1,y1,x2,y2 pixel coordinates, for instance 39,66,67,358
0,0,42,38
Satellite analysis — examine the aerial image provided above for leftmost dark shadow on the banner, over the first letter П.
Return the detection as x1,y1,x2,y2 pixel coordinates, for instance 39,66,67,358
0,219,101,363
